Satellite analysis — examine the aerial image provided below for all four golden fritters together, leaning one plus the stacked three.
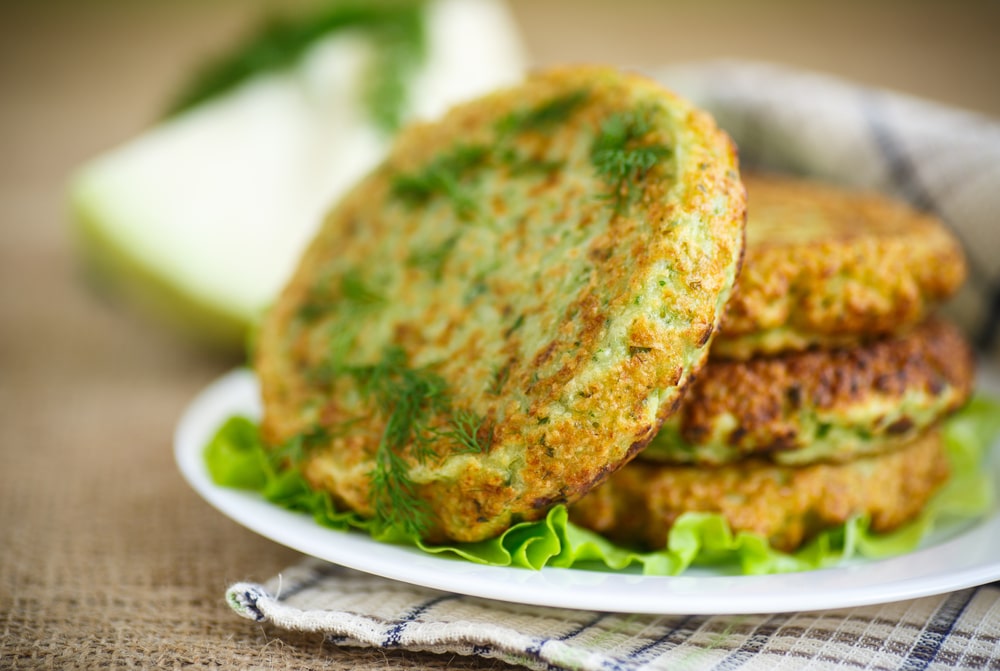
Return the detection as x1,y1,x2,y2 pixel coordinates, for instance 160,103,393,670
256,68,972,550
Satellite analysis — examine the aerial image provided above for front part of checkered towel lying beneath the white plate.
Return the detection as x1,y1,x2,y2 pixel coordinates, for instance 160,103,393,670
227,559,1000,671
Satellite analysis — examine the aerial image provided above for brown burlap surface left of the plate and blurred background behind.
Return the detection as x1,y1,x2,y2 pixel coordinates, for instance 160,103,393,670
0,0,1000,669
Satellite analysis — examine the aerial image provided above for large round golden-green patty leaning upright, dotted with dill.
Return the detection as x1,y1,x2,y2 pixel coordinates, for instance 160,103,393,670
256,68,745,541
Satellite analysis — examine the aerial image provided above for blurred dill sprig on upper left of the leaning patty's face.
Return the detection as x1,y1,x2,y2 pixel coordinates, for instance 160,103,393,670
392,144,489,220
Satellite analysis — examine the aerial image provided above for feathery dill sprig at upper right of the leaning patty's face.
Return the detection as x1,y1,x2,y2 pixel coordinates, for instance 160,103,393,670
590,106,671,214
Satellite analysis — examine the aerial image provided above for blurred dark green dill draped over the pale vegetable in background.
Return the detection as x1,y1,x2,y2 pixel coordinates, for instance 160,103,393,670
166,0,426,131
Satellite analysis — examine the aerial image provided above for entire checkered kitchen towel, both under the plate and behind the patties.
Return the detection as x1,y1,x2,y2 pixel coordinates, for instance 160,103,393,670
228,62,1000,671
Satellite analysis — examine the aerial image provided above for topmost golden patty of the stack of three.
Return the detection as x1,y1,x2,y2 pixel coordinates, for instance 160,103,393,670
712,174,966,359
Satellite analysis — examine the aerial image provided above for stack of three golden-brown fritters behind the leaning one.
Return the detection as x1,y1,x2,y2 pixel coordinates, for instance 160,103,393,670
571,175,973,550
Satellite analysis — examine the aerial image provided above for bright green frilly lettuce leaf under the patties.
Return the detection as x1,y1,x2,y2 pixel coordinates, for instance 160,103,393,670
204,396,1000,575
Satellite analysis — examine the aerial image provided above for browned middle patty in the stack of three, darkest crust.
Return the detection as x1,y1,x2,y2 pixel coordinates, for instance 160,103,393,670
641,319,975,464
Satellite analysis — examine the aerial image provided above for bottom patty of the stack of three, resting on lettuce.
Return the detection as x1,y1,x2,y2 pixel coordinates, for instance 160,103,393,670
570,429,948,551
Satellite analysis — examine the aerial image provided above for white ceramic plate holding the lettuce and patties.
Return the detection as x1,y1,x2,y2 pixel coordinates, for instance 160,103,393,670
175,370,1000,614
